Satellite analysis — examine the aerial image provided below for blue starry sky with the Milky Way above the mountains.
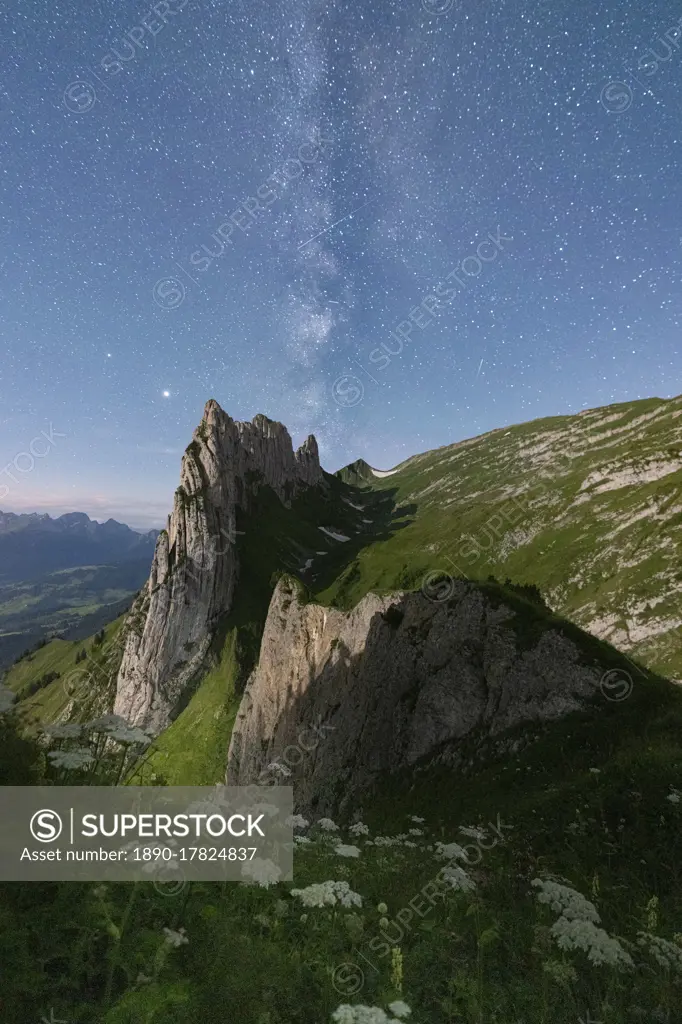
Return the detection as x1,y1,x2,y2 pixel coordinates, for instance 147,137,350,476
0,0,682,526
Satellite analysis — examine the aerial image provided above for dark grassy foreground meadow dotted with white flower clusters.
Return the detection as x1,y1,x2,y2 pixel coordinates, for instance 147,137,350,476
0,655,682,1024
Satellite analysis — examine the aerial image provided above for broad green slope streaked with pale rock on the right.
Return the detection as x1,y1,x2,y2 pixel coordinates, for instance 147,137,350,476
317,398,682,678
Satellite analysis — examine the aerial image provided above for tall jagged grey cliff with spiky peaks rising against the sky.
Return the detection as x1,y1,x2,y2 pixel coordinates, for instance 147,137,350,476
115,400,323,732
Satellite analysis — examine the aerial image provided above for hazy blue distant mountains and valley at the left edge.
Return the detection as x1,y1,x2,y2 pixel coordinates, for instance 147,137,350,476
0,512,158,669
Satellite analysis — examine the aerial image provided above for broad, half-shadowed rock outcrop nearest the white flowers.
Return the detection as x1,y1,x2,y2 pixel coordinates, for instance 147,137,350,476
227,579,600,814
